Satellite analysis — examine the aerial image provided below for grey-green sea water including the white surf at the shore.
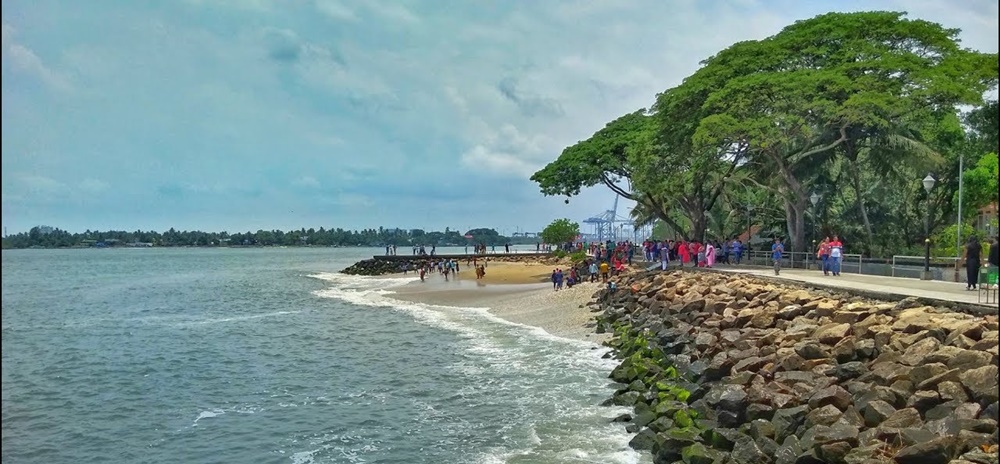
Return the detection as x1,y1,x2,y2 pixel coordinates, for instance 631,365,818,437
2,248,647,464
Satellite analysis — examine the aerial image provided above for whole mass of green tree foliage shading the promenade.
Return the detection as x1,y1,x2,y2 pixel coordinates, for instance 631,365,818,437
531,11,998,254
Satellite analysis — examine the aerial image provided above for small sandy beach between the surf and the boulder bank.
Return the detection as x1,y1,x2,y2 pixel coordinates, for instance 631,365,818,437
396,262,607,344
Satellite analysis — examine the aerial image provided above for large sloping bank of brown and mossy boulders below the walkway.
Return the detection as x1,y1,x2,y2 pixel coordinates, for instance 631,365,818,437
591,271,998,464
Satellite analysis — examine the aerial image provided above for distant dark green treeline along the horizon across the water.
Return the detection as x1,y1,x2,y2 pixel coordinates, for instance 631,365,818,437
3,226,537,249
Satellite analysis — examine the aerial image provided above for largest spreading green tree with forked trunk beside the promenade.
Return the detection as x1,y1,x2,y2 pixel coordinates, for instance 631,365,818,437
693,12,997,251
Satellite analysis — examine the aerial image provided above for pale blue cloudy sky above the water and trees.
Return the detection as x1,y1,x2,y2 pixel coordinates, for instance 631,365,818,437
2,0,998,234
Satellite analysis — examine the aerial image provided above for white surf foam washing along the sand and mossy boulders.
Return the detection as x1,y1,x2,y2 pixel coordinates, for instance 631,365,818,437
310,274,648,464
